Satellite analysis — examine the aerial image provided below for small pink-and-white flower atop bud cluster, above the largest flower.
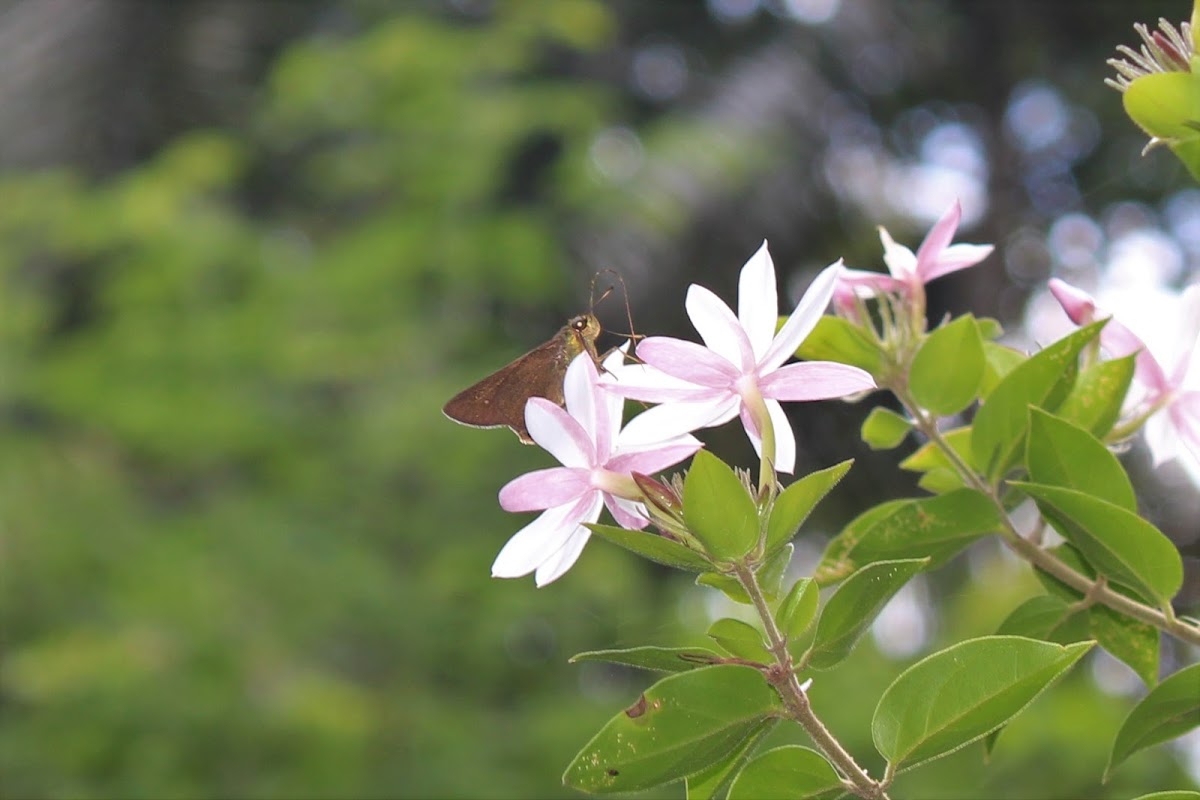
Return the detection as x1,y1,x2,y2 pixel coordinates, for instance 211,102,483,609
834,200,992,308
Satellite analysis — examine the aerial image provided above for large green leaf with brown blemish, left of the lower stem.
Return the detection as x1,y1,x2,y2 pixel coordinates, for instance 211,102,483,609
563,664,781,794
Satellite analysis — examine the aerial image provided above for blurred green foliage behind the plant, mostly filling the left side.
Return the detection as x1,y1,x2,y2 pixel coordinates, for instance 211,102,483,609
0,0,1184,799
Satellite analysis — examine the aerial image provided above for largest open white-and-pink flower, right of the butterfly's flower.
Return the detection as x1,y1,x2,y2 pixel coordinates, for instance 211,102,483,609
601,242,875,473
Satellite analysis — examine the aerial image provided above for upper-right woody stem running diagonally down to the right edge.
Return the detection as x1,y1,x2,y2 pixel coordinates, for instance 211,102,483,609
893,389,1200,645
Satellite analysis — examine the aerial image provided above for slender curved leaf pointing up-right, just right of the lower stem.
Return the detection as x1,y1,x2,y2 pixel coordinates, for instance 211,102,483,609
804,559,929,669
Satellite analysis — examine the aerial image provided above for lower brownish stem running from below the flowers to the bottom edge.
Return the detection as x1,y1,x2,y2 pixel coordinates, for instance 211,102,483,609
733,564,888,800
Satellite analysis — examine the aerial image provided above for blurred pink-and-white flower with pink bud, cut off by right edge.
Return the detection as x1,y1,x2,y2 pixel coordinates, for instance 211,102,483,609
1050,278,1200,474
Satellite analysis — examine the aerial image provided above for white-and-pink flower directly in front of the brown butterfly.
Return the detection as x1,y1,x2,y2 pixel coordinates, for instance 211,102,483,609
492,351,701,587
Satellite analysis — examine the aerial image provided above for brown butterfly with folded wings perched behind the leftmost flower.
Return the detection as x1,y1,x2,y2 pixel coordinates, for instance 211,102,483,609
442,312,600,445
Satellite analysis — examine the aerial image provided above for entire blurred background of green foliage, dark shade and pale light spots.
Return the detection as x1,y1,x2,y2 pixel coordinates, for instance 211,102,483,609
0,0,1200,799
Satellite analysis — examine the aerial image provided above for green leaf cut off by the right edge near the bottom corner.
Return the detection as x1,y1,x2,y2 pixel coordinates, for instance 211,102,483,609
1104,664,1200,780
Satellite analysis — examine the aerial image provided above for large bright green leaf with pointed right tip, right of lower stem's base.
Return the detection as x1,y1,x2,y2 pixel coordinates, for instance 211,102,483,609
871,636,1094,768
